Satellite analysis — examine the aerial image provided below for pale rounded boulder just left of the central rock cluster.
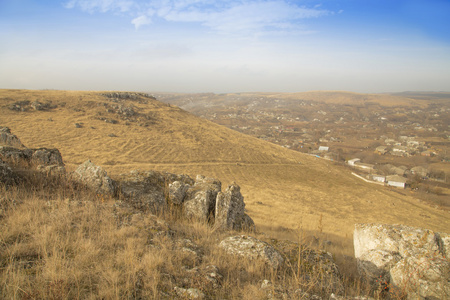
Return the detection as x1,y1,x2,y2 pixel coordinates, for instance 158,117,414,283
72,160,116,195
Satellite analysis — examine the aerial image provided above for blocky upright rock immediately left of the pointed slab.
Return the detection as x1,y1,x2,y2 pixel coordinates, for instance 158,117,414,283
183,175,222,221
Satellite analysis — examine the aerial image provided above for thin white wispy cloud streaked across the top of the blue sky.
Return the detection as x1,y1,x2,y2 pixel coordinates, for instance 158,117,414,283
65,0,333,34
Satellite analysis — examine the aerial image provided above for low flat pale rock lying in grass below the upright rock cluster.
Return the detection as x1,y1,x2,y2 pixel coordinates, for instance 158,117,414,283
219,235,284,269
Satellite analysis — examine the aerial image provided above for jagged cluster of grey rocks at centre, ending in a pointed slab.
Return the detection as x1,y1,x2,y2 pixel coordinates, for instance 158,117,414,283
119,170,254,230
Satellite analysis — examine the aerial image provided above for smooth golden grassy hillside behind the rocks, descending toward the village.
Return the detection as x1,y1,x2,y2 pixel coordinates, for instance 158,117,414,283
0,90,450,237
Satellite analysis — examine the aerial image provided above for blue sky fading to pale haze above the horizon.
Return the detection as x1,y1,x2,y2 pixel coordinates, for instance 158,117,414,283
0,0,450,93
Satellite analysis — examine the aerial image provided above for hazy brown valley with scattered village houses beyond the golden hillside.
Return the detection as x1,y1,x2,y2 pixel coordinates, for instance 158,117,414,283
157,93,450,208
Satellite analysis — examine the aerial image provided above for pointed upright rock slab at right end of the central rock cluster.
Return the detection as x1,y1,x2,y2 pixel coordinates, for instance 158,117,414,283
215,183,254,230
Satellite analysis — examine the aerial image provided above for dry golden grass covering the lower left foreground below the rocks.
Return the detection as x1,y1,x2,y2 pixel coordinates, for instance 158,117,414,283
0,170,356,299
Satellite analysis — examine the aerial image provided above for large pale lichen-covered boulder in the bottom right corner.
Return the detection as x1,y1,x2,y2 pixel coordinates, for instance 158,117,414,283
354,224,450,299
